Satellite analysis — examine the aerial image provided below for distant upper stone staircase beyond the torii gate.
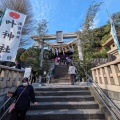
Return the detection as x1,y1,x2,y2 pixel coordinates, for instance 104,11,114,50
50,65,70,83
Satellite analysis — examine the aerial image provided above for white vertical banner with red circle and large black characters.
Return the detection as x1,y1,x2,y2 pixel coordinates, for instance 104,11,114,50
0,9,26,62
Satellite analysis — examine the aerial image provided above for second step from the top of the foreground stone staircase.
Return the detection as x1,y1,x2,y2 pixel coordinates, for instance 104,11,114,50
35,90,91,96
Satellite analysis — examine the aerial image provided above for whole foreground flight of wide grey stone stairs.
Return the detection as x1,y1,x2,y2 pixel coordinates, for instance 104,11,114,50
26,85,105,120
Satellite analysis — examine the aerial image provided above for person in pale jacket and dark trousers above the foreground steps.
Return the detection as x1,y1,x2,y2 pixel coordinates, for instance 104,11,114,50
68,63,76,85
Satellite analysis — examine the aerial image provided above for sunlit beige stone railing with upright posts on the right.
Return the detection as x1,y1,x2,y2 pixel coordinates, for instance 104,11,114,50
91,59,120,108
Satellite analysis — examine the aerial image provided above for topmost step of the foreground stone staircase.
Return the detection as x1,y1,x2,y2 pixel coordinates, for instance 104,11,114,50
35,86,88,91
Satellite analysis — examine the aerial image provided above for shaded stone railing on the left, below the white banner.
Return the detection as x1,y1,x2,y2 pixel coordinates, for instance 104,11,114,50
0,65,24,101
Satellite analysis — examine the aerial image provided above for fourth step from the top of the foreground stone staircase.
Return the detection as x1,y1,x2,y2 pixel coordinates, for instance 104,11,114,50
30,101,99,110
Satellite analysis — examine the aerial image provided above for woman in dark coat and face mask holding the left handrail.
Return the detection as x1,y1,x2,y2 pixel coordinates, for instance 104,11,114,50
8,77,38,120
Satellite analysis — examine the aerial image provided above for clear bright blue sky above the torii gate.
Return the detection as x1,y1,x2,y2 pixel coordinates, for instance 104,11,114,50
31,0,120,34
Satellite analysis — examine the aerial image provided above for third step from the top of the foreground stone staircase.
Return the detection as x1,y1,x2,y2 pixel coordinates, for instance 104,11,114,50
36,95,94,102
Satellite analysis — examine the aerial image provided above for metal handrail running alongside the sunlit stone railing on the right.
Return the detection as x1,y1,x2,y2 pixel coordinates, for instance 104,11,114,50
81,66,120,120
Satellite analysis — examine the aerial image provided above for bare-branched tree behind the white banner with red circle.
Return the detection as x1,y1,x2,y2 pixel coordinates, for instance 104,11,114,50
0,0,34,46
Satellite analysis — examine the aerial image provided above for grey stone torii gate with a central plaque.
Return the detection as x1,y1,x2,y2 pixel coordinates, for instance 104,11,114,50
30,31,83,67
